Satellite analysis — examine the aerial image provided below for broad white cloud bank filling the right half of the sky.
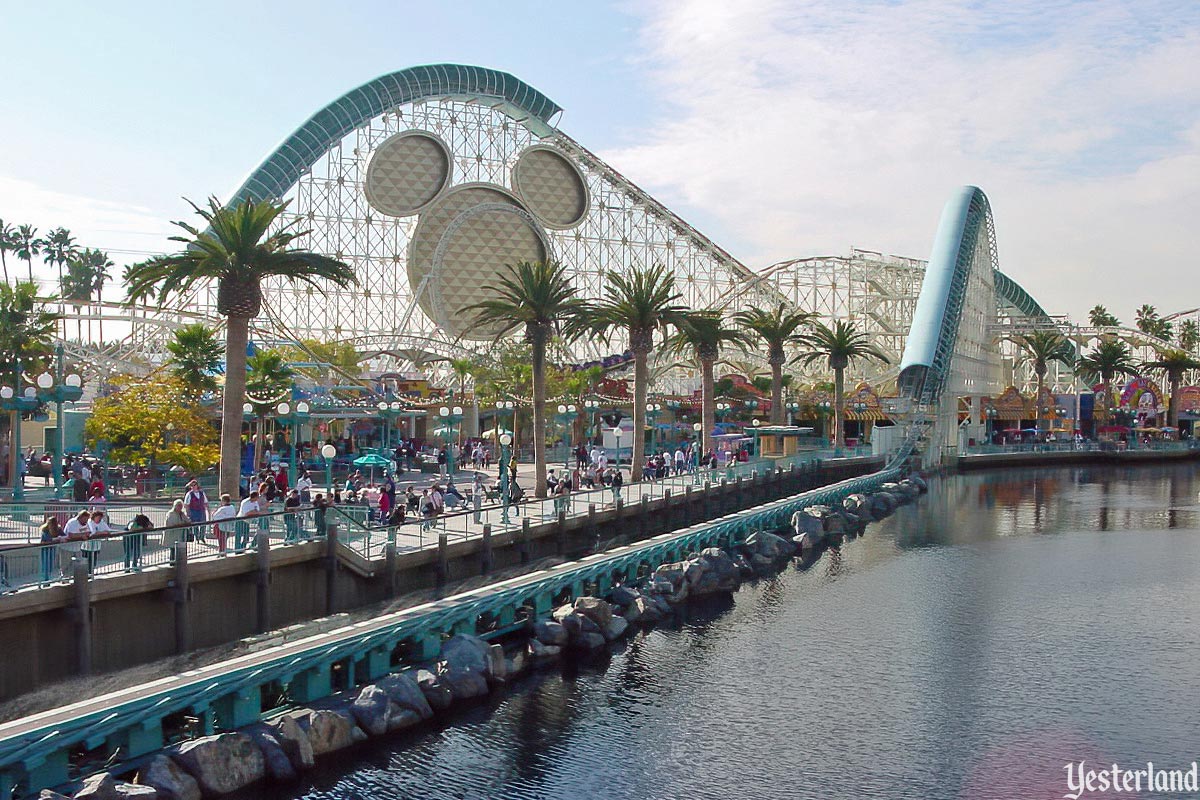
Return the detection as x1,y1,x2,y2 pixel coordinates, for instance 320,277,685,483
604,0,1200,317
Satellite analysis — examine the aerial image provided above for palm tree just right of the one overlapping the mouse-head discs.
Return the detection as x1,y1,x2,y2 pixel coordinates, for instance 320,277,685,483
590,264,686,481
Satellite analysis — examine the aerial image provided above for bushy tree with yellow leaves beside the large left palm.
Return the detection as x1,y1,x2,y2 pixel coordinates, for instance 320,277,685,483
84,377,221,473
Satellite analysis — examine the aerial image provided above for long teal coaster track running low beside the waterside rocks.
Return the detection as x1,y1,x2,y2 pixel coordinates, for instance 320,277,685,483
0,467,902,800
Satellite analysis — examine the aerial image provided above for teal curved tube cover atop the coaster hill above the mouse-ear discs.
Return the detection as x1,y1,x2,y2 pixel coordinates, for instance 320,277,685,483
229,64,563,205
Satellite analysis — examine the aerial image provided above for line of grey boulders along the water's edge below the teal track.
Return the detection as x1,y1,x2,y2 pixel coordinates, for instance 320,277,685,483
32,476,926,800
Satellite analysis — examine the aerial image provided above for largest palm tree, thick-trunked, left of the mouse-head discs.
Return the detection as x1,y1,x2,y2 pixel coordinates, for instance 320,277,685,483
125,198,358,494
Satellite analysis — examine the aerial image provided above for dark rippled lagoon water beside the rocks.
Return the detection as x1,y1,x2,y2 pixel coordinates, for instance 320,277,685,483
258,467,1200,800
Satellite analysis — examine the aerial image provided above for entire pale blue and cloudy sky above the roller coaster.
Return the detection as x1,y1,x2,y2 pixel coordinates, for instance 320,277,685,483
0,0,1200,320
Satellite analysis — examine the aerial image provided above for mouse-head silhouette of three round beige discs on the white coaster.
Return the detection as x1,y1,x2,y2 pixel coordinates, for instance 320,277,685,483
364,131,589,341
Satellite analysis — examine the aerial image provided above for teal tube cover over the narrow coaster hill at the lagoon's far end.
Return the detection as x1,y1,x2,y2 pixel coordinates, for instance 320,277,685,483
898,186,1049,403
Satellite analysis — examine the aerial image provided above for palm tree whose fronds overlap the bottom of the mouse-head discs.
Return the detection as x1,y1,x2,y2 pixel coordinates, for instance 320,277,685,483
467,261,588,498
